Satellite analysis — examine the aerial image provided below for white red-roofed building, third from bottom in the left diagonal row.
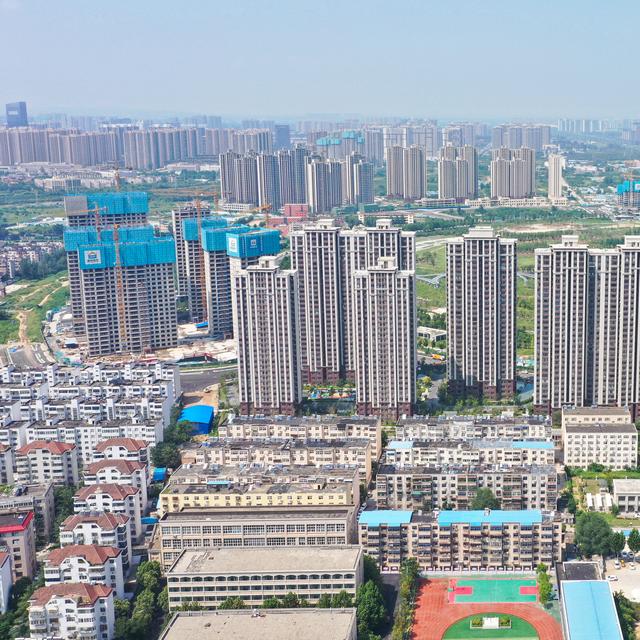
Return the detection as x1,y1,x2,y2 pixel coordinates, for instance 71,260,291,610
60,511,131,574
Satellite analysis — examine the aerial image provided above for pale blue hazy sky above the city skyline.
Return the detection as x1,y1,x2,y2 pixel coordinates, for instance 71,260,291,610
0,0,640,118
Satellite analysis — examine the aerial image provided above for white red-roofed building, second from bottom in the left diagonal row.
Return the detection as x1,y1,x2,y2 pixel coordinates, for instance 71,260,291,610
44,544,124,598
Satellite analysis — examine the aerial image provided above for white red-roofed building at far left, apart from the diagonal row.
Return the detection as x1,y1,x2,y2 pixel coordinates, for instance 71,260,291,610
15,440,80,485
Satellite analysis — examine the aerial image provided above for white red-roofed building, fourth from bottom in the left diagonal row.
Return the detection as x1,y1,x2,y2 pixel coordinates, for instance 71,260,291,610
73,483,143,542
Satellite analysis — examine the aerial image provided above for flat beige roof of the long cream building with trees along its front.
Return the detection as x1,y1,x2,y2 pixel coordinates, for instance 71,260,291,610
169,545,362,575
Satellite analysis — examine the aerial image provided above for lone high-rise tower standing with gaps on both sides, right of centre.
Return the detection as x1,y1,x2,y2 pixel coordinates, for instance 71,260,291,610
447,227,516,398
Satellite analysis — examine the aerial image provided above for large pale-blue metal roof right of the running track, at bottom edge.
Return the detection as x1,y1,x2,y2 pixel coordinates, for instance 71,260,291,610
562,580,622,640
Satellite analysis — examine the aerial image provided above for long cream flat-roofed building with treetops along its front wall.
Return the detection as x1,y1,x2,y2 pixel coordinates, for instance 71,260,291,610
167,545,363,609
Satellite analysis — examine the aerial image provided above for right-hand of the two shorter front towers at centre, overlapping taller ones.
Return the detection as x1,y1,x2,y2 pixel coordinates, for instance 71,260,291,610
353,257,416,419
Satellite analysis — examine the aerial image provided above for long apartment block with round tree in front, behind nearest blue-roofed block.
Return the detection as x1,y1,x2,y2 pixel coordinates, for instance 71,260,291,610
375,464,558,511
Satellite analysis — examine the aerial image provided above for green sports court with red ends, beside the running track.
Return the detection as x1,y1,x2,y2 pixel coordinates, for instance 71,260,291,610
448,578,538,604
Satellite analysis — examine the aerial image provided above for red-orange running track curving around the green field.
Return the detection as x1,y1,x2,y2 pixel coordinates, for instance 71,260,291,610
412,579,562,640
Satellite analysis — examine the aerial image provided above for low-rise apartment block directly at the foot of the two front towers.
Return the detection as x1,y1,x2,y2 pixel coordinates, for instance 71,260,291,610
218,415,382,460
